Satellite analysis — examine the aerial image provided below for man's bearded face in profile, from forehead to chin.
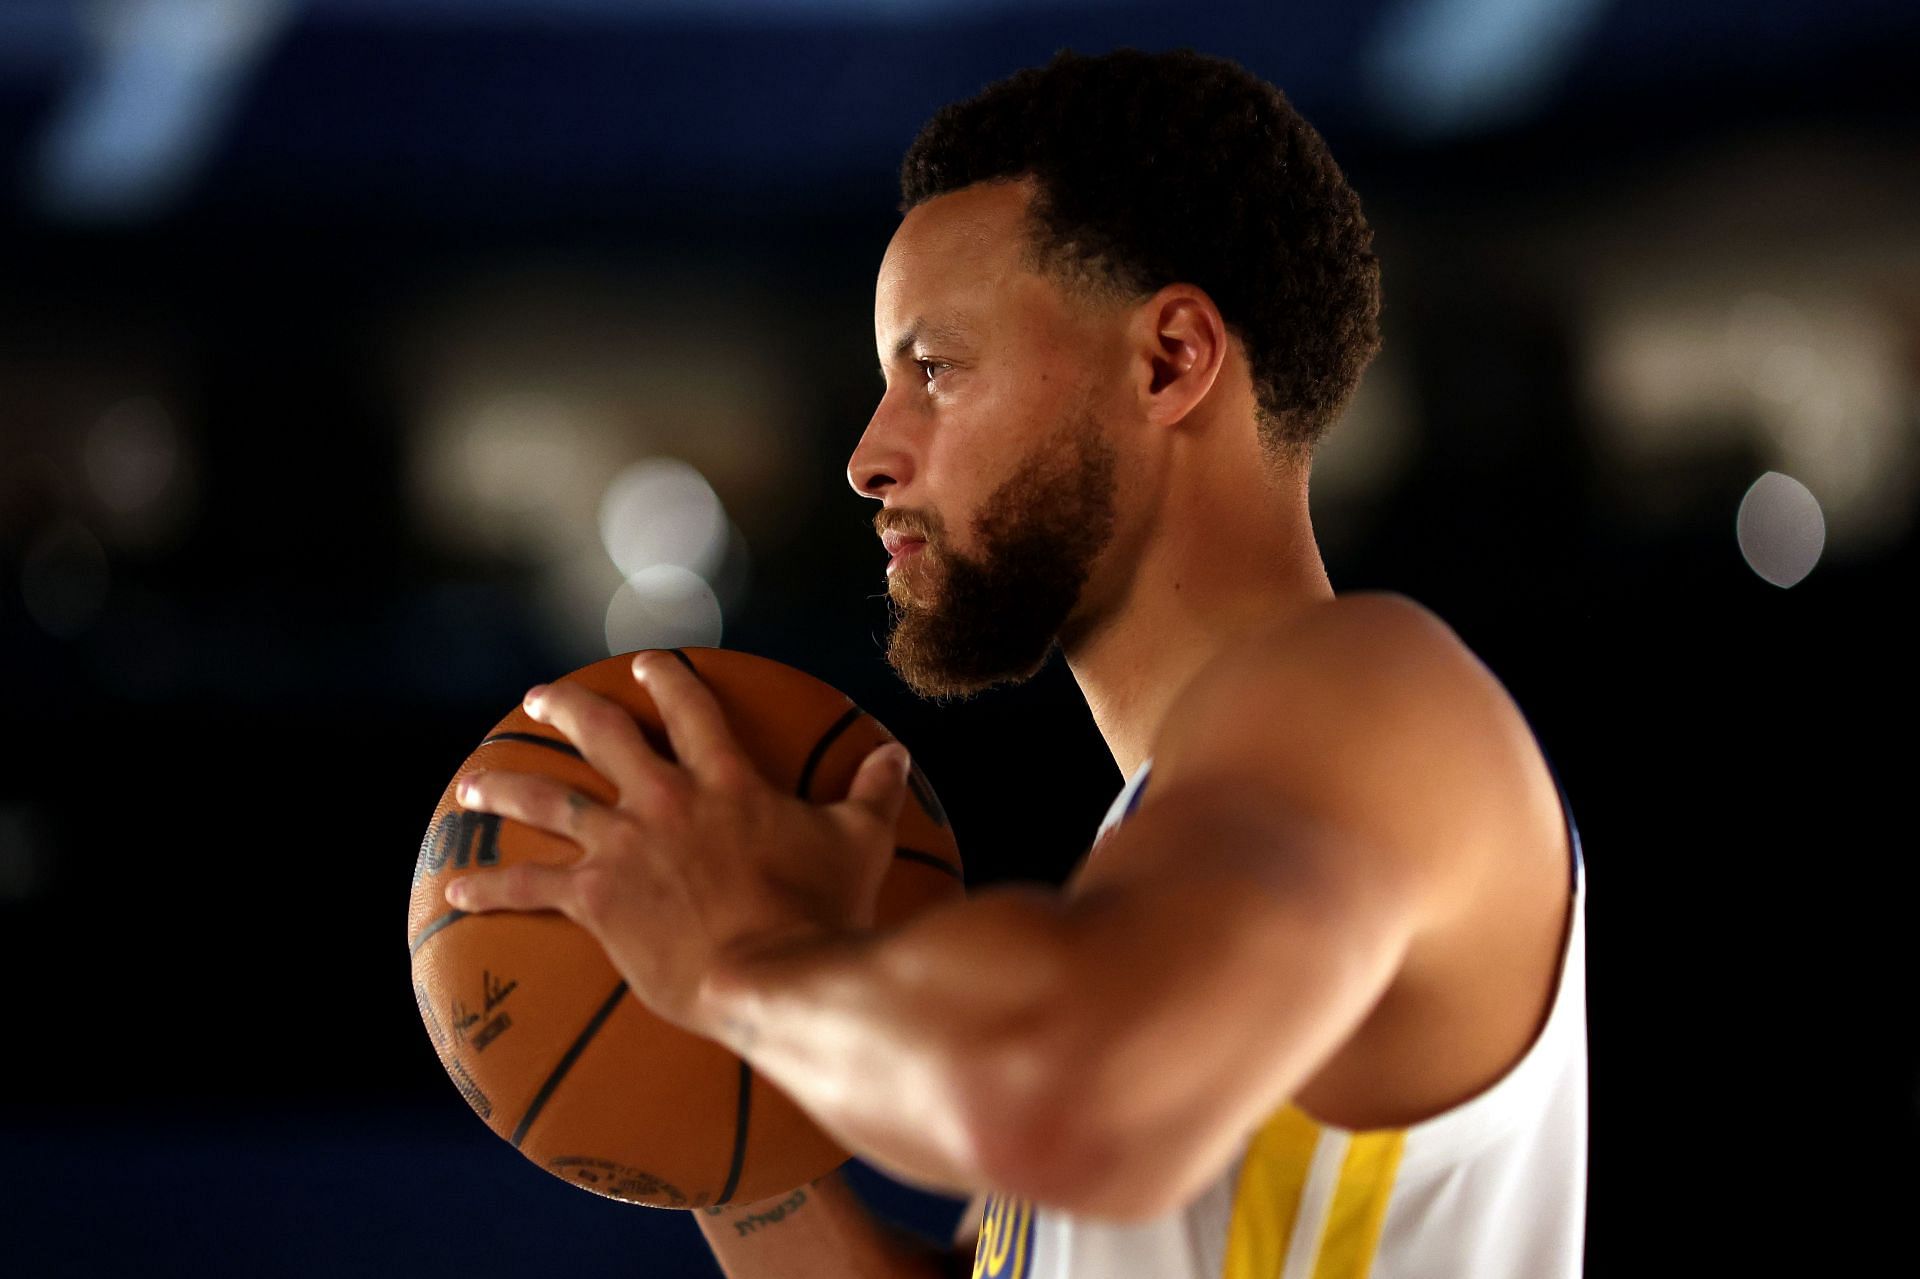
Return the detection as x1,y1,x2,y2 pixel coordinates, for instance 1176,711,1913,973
847,182,1123,697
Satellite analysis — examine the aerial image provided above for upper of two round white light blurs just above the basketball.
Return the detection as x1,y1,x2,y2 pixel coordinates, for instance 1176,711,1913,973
599,457,728,580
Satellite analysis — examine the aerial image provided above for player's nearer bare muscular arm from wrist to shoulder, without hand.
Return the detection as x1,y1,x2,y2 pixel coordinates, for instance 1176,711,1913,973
701,605,1497,1219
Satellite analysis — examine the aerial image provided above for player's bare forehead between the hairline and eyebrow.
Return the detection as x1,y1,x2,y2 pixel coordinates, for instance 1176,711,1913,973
874,182,1043,341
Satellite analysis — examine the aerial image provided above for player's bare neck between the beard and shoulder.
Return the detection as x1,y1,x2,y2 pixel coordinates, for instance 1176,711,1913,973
1062,430,1334,778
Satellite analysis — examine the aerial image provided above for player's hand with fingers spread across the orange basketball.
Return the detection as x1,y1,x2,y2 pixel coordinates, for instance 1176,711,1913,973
447,651,908,1037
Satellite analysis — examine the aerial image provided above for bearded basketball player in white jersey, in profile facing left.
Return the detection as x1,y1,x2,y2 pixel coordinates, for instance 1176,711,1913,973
451,50,1586,1279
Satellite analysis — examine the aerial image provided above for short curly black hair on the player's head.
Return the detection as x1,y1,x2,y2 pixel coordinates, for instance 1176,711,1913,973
900,48,1380,459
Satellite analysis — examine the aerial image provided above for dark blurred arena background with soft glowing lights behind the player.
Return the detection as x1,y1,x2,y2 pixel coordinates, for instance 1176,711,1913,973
0,0,1920,1279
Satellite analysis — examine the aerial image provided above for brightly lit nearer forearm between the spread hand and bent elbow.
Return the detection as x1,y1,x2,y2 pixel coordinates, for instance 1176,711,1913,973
701,887,1066,1195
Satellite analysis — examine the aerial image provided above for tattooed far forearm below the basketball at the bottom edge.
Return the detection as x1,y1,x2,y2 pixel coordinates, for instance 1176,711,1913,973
693,1170,954,1279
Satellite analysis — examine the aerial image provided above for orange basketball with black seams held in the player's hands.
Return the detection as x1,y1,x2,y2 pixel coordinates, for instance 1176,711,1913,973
407,647,964,1208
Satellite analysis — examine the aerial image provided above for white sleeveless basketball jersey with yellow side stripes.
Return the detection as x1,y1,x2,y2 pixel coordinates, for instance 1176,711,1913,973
973,748,1586,1279
